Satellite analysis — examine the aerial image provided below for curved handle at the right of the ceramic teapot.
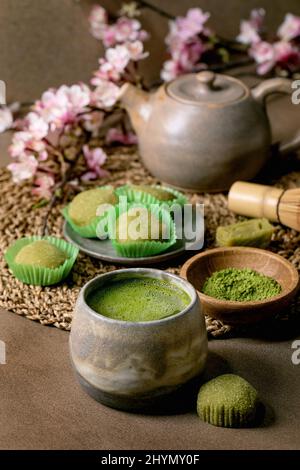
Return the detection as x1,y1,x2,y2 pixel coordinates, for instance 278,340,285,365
252,78,300,155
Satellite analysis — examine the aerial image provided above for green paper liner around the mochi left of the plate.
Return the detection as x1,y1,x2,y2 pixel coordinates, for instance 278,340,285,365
4,236,79,286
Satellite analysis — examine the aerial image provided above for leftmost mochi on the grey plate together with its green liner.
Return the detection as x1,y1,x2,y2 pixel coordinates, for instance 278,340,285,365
63,186,118,238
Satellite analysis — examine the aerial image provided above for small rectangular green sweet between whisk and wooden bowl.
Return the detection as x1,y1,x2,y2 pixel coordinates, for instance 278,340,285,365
216,219,274,248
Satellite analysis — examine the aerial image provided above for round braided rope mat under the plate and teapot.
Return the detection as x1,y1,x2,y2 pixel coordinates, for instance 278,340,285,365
0,148,300,337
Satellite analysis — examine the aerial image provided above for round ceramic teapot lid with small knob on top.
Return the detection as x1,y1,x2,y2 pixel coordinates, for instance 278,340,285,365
167,70,248,105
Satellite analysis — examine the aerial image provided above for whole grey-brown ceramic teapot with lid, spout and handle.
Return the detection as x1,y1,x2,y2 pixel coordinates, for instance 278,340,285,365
121,71,300,191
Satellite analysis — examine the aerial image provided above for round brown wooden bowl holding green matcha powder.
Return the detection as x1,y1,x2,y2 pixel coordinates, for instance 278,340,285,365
180,247,299,324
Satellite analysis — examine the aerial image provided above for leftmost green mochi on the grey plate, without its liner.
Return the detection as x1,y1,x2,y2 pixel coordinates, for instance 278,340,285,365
68,188,118,227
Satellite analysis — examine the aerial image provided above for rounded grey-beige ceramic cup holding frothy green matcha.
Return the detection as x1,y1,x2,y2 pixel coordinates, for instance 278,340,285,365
70,268,207,411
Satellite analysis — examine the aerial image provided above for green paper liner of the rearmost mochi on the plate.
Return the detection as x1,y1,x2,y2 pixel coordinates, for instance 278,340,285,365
116,184,187,207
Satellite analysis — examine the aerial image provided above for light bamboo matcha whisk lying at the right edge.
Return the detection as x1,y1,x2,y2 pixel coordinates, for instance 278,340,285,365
228,181,300,231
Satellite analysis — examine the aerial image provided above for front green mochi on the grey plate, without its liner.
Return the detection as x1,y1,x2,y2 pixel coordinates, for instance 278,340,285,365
116,207,166,243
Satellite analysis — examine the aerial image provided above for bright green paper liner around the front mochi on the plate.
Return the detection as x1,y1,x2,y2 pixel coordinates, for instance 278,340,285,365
108,203,176,258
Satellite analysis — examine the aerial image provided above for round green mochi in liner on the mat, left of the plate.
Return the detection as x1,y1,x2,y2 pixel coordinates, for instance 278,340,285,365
15,240,68,269
